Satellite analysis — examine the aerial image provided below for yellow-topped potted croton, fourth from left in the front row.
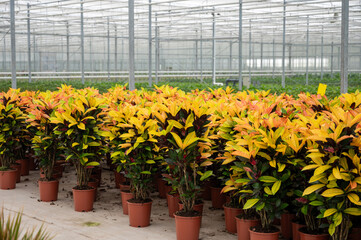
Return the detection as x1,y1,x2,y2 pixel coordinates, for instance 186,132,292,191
104,105,159,227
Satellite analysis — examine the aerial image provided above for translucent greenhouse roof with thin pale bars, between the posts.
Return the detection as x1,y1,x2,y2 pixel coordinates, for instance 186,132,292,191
0,0,361,48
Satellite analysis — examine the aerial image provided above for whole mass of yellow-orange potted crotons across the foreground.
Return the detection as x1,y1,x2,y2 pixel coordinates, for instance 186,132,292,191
0,86,361,240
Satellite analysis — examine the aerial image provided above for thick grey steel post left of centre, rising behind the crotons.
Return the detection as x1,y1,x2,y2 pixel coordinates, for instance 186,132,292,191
128,0,135,91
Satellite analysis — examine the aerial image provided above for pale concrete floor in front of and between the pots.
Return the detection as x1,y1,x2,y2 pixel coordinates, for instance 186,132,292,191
0,166,237,240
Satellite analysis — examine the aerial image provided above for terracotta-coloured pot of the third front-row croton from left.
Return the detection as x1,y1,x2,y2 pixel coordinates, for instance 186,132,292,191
73,188,95,212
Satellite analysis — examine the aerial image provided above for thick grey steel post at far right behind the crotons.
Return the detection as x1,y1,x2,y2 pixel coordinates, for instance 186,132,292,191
341,0,349,94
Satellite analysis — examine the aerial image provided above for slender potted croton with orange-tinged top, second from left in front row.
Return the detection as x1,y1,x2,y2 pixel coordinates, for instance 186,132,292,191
27,92,65,202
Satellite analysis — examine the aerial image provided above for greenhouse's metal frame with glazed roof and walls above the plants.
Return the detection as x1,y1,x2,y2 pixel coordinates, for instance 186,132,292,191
0,0,361,92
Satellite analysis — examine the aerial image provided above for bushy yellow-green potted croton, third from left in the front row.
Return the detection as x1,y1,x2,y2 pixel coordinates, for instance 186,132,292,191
50,89,104,212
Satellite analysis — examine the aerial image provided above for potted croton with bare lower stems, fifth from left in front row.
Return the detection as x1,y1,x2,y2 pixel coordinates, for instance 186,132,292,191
158,100,212,240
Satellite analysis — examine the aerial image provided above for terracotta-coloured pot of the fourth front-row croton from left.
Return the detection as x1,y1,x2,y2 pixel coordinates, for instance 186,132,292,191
128,200,152,227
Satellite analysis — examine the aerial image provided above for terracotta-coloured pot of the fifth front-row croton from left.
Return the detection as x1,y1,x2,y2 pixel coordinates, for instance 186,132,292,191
175,214,201,240
